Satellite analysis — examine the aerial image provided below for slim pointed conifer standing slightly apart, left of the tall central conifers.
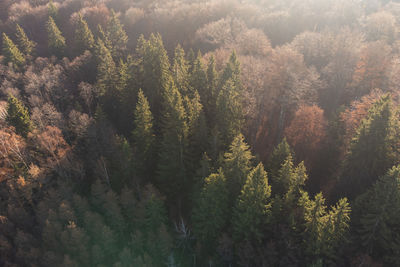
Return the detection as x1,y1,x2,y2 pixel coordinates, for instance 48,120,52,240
132,90,155,182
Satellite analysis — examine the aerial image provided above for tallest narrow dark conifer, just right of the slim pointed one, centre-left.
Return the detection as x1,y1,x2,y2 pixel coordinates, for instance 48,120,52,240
157,81,187,207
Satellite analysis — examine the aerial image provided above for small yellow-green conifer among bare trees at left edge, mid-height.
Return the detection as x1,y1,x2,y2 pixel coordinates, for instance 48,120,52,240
6,95,32,137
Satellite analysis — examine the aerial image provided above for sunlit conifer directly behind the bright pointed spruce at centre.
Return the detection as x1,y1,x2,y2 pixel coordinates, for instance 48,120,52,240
216,80,243,148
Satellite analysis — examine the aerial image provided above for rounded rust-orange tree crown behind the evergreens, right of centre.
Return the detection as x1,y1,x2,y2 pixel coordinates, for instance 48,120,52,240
285,105,327,163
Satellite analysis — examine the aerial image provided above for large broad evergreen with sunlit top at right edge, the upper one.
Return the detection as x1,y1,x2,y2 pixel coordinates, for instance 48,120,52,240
339,95,400,197
